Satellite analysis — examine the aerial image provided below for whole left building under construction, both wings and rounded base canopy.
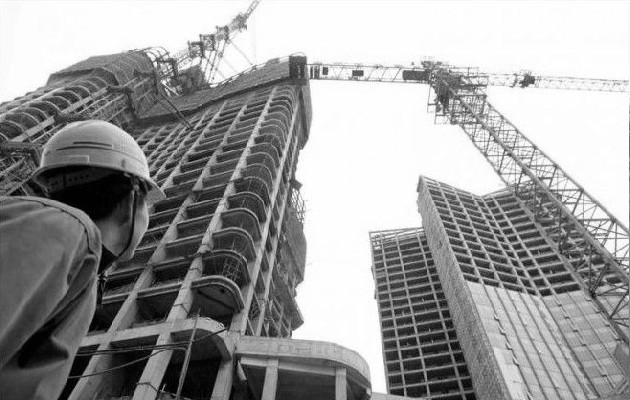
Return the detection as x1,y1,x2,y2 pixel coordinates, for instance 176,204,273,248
0,51,410,400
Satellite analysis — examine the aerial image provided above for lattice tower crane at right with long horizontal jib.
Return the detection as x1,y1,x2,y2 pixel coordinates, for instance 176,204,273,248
309,61,630,343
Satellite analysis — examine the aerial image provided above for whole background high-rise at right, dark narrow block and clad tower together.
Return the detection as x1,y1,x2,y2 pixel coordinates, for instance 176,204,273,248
371,177,628,400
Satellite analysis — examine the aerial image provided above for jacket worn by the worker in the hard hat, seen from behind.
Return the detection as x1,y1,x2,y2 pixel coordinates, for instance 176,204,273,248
0,197,101,400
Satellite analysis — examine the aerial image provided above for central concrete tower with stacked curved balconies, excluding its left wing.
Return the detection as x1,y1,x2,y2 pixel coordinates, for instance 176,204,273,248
66,53,311,398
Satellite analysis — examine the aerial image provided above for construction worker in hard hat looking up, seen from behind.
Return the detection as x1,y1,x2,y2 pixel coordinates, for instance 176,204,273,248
0,120,164,400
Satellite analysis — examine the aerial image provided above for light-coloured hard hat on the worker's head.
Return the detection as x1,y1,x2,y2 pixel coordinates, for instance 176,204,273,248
35,120,166,203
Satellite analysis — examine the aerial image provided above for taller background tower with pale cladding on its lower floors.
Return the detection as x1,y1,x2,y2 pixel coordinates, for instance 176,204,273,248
418,178,624,399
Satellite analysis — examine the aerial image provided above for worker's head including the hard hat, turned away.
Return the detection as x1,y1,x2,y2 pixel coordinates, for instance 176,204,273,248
35,120,164,260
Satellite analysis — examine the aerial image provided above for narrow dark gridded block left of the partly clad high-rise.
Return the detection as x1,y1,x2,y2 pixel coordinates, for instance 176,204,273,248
370,228,475,400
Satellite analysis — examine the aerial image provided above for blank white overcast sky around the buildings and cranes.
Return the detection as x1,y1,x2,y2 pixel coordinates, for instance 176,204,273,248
0,0,630,392
